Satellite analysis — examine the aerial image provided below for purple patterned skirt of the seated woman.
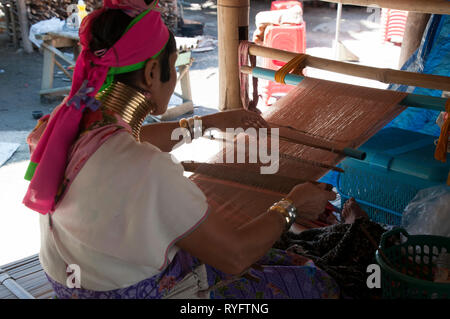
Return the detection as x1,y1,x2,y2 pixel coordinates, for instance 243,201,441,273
47,249,339,299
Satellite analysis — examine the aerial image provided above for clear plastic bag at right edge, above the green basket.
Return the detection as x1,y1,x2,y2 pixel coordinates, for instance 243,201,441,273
402,185,450,237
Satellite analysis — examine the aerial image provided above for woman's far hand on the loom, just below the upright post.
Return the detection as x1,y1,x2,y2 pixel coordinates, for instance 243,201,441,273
217,109,270,131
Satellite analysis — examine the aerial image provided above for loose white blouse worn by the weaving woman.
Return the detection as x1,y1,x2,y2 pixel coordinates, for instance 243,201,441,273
40,132,208,291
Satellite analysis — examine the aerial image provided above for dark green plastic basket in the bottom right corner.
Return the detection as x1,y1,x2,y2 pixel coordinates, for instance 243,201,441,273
376,228,450,299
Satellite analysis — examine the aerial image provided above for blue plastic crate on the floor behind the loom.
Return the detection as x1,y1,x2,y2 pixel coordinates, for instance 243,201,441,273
336,128,450,225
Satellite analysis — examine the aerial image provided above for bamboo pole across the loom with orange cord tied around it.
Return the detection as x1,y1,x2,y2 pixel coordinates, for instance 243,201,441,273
249,44,450,91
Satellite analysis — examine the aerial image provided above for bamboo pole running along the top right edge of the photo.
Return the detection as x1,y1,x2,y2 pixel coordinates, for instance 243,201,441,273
322,0,450,14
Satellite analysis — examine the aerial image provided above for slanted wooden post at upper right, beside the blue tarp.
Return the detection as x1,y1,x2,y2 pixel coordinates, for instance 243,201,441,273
399,12,430,68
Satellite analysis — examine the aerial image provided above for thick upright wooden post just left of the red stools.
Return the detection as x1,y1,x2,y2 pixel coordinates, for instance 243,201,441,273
217,0,250,111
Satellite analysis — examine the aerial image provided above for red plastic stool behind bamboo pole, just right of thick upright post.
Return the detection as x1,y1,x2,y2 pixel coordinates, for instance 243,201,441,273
263,22,306,105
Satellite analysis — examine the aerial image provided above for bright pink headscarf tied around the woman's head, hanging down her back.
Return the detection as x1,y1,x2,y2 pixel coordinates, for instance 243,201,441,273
23,0,169,214
